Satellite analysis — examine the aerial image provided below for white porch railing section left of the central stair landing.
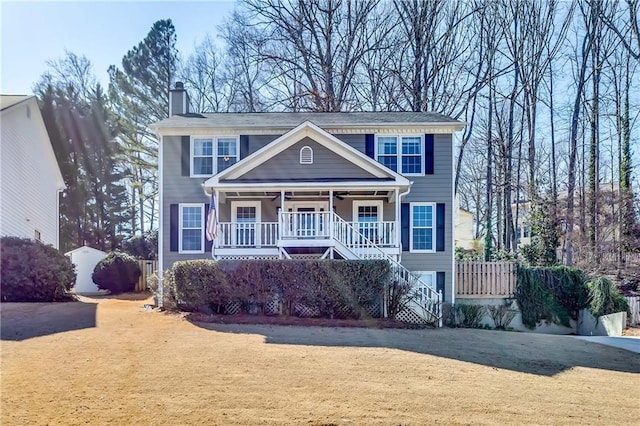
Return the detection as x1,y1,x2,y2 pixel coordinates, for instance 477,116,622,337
216,222,278,248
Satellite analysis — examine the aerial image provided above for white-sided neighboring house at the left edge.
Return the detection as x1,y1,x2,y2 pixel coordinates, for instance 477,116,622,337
0,95,65,248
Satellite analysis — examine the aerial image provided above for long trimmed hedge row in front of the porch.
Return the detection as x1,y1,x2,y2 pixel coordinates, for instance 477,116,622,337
165,260,390,318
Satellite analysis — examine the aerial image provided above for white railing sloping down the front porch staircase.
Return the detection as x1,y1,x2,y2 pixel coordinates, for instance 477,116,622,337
332,213,442,326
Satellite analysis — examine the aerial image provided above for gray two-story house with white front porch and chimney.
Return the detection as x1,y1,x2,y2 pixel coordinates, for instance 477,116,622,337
152,83,463,320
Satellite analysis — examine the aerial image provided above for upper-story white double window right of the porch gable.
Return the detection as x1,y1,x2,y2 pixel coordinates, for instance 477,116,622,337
376,135,424,175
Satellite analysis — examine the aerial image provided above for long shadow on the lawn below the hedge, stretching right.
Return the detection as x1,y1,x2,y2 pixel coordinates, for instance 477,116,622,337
194,322,640,376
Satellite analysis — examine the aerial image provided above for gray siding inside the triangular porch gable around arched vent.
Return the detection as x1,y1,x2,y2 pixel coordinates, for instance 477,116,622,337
235,137,375,180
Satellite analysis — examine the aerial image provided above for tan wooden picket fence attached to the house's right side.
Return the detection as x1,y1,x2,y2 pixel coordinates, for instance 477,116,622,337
456,262,516,298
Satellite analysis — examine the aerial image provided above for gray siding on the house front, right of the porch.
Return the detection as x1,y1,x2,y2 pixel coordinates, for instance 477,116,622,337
402,135,454,302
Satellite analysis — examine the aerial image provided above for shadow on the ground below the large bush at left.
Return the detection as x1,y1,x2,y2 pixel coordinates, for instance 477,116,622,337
0,302,97,341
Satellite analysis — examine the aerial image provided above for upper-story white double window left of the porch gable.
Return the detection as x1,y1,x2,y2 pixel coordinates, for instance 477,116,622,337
191,136,240,177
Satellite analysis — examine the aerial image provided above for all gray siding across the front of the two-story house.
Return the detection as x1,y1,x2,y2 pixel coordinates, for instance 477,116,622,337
161,134,454,301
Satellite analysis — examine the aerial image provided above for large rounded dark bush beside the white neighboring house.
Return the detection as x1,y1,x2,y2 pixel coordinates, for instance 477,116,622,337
0,237,76,302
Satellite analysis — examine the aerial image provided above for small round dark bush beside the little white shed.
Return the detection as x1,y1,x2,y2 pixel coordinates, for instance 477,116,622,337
91,251,142,294
